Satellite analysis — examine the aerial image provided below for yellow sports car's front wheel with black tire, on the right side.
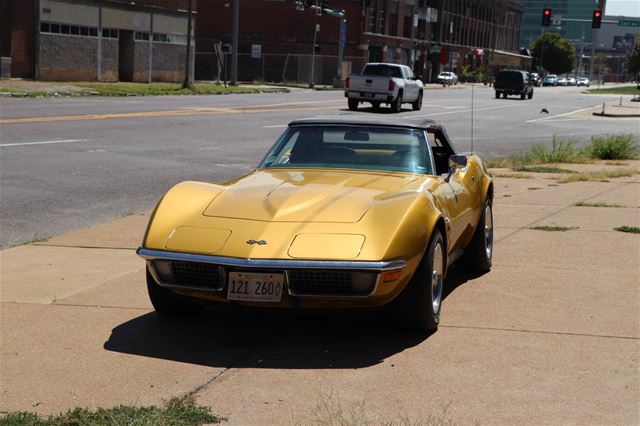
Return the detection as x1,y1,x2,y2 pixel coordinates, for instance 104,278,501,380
397,228,446,333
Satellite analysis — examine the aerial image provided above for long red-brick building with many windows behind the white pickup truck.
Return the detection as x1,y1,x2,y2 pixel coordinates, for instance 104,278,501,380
196,0,530,83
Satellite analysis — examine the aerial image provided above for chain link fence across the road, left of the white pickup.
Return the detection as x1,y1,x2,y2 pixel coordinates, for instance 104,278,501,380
195,52,367,84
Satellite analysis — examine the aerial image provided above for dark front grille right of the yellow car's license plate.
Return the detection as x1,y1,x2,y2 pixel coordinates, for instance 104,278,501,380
288,269,377,296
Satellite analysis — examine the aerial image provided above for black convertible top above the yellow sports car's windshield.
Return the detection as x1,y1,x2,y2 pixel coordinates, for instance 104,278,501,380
289,113,441,130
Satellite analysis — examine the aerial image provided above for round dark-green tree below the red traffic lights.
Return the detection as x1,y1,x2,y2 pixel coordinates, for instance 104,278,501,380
531,32,576,74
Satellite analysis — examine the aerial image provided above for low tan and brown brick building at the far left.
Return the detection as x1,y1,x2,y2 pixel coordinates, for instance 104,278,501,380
0,0,195,82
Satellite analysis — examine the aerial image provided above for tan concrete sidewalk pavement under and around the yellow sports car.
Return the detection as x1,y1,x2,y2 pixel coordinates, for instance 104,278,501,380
0,161,640,425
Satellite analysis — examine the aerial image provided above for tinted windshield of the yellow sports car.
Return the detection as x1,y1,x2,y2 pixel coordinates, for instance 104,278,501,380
259,126,433,174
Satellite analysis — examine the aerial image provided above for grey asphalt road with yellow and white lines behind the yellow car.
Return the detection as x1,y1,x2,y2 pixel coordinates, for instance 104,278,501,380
0,86,640,248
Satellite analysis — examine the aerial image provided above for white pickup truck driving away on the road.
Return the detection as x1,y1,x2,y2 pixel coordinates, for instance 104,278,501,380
344,62,424,112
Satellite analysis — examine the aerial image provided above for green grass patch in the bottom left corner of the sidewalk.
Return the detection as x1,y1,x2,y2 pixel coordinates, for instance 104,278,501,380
0,395,226,426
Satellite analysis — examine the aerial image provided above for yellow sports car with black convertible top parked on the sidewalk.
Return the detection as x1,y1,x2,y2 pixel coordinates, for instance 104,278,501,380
138,115,493,331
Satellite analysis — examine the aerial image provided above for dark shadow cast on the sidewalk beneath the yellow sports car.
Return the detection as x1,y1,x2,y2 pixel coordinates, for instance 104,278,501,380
104,262,482,369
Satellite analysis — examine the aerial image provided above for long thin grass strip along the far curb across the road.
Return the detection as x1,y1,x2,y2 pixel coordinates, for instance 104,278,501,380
73,82,282,96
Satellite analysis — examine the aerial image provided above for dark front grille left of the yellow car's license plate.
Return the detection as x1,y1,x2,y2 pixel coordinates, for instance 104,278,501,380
154,260,223,289
